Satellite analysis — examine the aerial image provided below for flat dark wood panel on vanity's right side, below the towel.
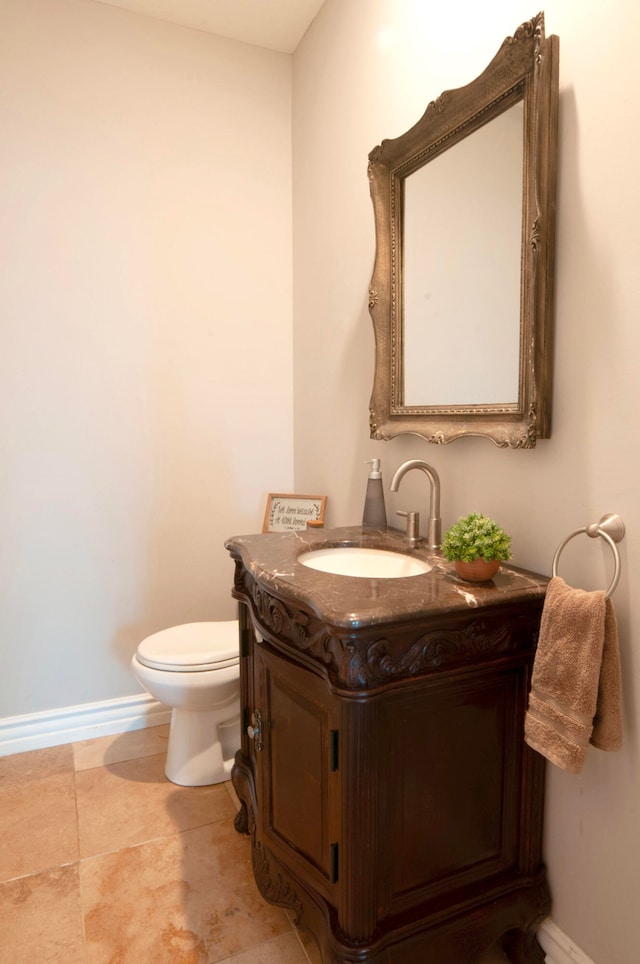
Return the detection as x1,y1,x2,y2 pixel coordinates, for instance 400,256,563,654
387,672,522,903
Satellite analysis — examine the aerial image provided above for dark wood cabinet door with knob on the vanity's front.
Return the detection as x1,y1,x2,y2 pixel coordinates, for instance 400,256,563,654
254,643,340,893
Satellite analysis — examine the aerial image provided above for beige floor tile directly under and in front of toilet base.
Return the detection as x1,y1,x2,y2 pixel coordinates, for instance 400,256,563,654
76,754,235,857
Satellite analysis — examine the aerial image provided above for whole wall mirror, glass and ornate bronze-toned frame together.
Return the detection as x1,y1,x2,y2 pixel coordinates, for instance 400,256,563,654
369,13,559,448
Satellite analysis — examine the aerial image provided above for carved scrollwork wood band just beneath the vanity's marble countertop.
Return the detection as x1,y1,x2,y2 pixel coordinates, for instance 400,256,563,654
234,559,539,689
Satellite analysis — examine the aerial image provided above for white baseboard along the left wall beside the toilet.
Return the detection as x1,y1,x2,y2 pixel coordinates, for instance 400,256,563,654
0,693,171,756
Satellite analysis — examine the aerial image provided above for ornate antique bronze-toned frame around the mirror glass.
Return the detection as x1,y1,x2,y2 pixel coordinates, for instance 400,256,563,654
369,13,559,448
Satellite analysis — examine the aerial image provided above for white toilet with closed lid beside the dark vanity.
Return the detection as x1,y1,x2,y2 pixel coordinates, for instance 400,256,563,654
131,619,240,787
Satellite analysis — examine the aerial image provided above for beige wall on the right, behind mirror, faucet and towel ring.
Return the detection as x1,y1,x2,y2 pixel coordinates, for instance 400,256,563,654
294,0,640,964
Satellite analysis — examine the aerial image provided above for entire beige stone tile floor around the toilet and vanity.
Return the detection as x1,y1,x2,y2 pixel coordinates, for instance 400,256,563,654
0,726,505,964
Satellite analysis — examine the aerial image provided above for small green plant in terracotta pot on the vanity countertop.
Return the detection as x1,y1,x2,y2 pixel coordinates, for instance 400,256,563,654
442,512,511,582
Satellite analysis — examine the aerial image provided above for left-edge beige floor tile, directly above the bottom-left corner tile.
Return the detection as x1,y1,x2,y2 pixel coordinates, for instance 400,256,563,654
0,773,78,880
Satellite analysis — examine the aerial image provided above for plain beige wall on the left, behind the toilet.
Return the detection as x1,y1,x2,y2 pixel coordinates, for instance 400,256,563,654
0,0,293,717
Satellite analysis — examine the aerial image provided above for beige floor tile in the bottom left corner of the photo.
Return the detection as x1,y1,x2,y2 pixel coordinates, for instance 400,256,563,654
0,864,85,964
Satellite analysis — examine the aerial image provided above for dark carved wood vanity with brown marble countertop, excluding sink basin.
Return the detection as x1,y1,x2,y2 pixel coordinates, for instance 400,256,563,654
227,527,550,964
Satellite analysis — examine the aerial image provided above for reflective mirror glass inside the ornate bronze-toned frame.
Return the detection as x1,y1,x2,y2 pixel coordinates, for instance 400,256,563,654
403,102,524,405
